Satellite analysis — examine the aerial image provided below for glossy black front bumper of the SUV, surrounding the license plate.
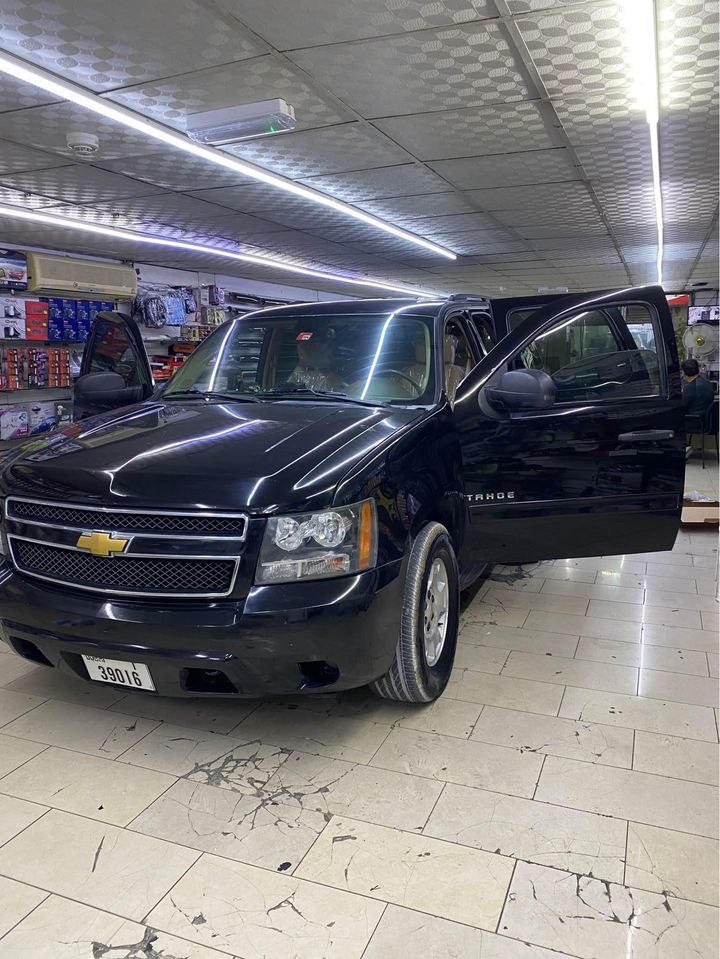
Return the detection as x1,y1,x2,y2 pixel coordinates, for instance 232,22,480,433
0,562,404,697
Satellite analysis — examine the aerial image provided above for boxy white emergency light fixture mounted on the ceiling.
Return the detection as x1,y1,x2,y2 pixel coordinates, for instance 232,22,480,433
187,99,295,146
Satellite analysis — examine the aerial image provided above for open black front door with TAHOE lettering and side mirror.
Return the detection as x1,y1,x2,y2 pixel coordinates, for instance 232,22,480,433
454,287,685,563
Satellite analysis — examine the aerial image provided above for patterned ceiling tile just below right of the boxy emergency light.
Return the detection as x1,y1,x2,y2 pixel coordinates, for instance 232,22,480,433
225,123,412,179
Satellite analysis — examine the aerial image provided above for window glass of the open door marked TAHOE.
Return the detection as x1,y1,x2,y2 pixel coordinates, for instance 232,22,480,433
518,304,661,403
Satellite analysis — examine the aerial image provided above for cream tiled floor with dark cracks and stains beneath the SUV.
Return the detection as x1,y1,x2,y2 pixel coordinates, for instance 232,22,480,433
0,528,718,959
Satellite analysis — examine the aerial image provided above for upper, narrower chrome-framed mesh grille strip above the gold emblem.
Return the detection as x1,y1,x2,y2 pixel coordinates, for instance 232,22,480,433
6,497,247,539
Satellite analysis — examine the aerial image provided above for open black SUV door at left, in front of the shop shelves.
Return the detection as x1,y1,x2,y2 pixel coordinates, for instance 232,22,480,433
73,312,153,420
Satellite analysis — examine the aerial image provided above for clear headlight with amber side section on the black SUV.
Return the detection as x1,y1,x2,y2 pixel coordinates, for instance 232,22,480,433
255,499,377,583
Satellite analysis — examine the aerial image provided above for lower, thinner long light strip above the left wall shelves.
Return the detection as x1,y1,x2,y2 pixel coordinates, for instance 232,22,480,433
0,203,437,296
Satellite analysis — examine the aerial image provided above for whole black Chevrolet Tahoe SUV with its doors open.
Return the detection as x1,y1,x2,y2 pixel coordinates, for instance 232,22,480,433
0,287,684,702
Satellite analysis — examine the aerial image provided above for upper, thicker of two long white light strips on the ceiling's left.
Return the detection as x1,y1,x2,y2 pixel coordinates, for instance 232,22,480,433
0,52,457,260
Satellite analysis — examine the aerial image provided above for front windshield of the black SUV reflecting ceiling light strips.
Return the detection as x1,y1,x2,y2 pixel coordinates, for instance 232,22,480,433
164,312,435,405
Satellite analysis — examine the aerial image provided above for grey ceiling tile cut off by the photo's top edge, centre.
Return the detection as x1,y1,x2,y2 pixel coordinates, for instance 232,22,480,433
223,0,496,50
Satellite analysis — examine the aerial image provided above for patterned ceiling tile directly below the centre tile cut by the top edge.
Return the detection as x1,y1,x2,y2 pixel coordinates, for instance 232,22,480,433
290,22,528,117
